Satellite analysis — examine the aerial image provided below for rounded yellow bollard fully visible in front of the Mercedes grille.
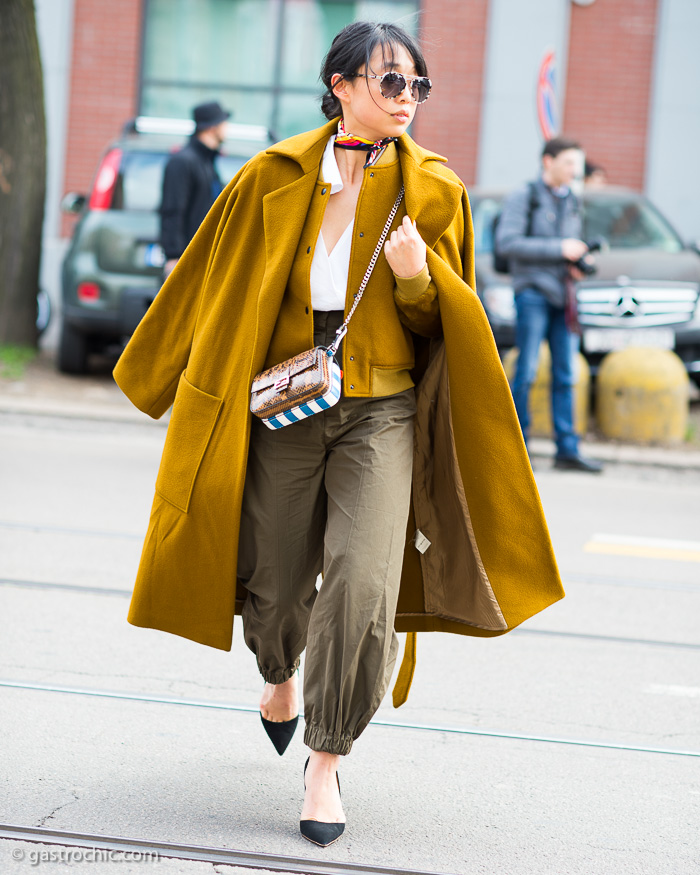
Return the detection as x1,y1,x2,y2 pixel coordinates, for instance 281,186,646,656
596,347,690,444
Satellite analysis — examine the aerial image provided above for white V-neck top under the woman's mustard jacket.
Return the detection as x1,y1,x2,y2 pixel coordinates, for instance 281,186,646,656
309,134,355,310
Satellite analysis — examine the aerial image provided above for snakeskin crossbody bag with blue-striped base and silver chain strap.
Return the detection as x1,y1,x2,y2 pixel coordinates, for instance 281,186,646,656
250,186,404,429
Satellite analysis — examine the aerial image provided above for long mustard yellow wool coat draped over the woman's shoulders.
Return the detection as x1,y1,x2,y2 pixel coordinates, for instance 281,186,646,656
114,122,564,684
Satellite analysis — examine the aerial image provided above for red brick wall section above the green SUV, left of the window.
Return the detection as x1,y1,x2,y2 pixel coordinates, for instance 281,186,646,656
61,0,142,236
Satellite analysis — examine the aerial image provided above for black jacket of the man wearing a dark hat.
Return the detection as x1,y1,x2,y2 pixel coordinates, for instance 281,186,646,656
160,137,223,258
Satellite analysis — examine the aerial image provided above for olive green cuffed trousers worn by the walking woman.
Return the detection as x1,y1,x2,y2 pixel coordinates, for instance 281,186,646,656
238,312,415,754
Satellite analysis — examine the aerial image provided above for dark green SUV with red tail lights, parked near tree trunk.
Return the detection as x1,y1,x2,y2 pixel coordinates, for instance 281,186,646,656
58,118,273,374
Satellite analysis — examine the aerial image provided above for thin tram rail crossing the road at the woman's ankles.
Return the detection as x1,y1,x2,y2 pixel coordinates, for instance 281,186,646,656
0,679,700,757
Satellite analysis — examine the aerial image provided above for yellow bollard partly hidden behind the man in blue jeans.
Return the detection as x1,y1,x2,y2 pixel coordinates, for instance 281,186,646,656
503,341,591,437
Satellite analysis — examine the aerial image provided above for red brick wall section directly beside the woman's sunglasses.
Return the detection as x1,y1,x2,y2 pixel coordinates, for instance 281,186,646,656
413,0,489,185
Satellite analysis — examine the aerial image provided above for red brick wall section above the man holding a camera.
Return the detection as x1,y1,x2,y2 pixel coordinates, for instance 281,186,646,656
563,0,657,190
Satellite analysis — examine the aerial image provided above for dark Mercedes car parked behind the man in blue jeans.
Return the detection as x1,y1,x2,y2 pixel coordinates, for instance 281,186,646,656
470,186,700,382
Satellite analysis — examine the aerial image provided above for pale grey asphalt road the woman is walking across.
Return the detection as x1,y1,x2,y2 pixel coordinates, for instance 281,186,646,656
0,413,700,875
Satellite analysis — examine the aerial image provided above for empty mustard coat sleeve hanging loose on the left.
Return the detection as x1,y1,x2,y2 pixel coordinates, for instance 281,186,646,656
114,165,247,419
